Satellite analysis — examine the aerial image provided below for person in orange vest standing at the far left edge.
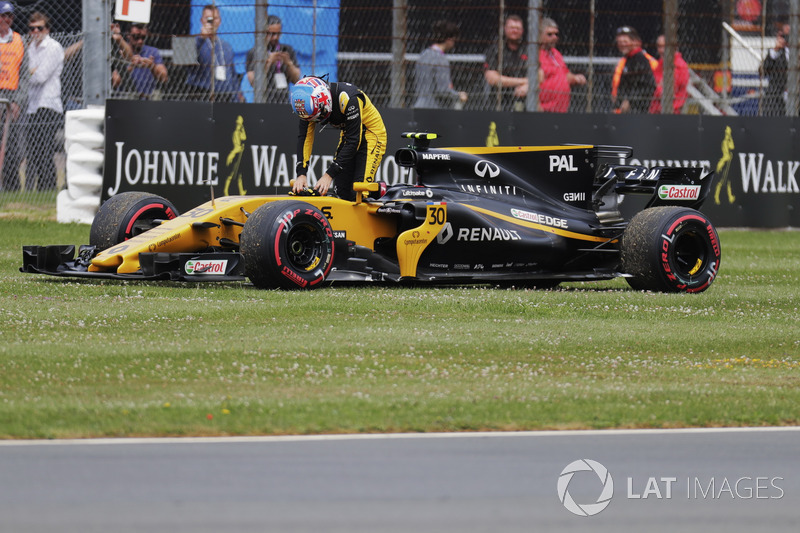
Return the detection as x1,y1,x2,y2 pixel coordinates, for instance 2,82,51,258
0,2,25,191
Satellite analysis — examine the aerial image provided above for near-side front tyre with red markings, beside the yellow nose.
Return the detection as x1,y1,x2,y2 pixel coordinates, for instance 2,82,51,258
239,200,334,289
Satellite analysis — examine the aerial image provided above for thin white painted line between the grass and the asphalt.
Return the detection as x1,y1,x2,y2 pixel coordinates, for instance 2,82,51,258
0,426,800,446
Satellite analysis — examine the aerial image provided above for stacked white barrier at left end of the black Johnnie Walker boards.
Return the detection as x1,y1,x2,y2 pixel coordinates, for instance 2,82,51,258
56,106,105,224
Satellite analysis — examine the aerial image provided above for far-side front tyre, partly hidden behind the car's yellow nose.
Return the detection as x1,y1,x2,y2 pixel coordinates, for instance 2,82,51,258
89,191,180,250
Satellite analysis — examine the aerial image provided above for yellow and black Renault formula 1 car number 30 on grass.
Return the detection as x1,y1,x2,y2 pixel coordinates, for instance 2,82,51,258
21,133,721,292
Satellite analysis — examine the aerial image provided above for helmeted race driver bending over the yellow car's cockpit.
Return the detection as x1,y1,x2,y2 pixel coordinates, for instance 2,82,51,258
291,77,386,201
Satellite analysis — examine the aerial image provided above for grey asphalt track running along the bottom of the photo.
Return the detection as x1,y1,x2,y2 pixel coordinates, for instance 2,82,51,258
0,428,800,533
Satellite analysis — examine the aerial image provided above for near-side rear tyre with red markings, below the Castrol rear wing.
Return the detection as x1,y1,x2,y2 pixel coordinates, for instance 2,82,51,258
622,206,721,292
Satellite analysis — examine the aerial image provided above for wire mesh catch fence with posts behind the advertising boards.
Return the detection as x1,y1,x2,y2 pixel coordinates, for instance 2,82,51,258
0,0,800,215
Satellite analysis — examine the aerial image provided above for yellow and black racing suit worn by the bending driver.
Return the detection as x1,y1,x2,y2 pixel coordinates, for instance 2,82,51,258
296,82,386,200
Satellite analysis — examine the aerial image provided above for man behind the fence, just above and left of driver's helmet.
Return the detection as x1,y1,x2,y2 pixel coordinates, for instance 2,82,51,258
246,15,300,104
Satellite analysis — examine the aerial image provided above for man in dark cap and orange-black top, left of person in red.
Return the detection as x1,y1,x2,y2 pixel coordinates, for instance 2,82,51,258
611,26,658,113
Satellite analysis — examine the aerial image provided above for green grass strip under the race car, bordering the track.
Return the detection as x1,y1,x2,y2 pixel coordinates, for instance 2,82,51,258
0,219,800,438
